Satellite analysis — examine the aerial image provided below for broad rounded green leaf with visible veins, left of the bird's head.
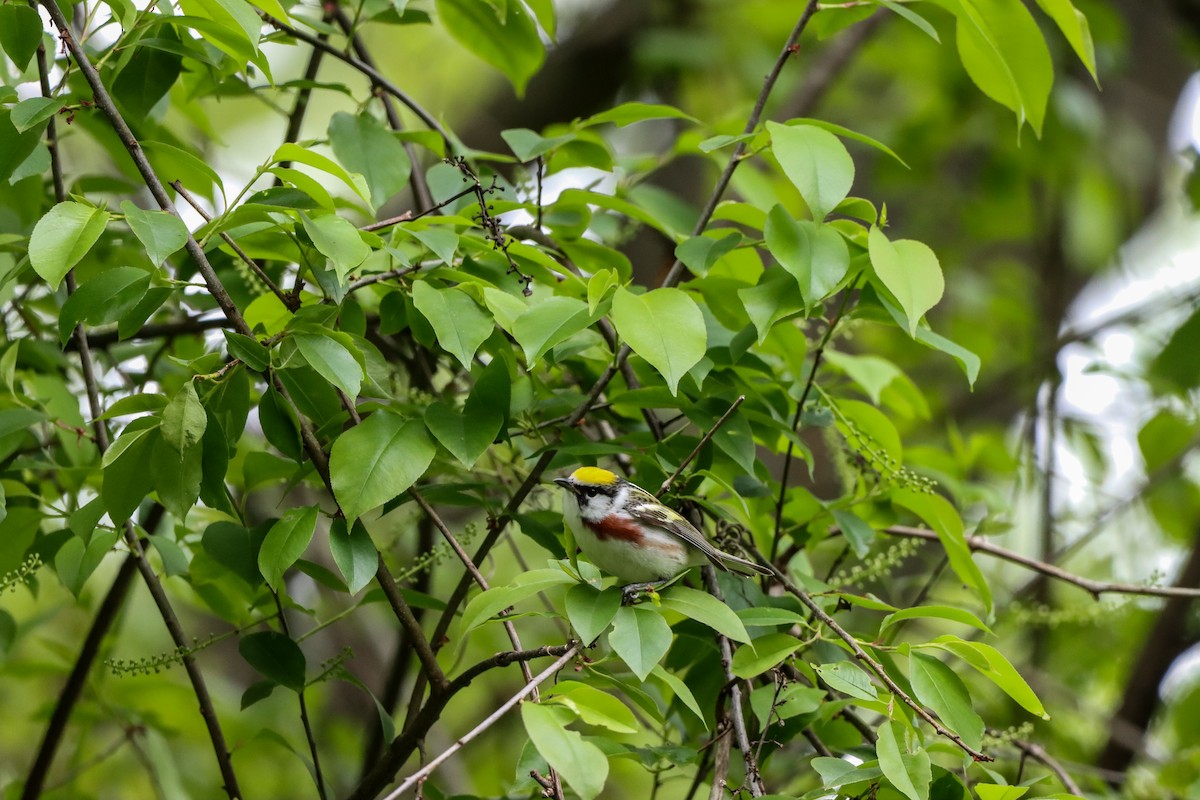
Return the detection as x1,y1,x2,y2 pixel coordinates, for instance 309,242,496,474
329,411,437,523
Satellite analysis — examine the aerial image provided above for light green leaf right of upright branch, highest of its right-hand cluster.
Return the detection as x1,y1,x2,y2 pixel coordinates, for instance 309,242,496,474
767,122,854,222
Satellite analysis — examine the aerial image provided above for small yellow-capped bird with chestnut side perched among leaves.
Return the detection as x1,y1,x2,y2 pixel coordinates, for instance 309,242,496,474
554,467,770,585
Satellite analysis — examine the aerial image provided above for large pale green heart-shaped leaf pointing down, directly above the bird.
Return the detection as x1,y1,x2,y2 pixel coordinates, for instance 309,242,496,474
612,288,708,395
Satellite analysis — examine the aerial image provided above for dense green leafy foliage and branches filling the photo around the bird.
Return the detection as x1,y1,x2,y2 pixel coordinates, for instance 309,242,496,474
0,0,1200,800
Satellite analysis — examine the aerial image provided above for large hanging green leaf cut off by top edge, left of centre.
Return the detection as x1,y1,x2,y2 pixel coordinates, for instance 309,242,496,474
437,0,546,97
